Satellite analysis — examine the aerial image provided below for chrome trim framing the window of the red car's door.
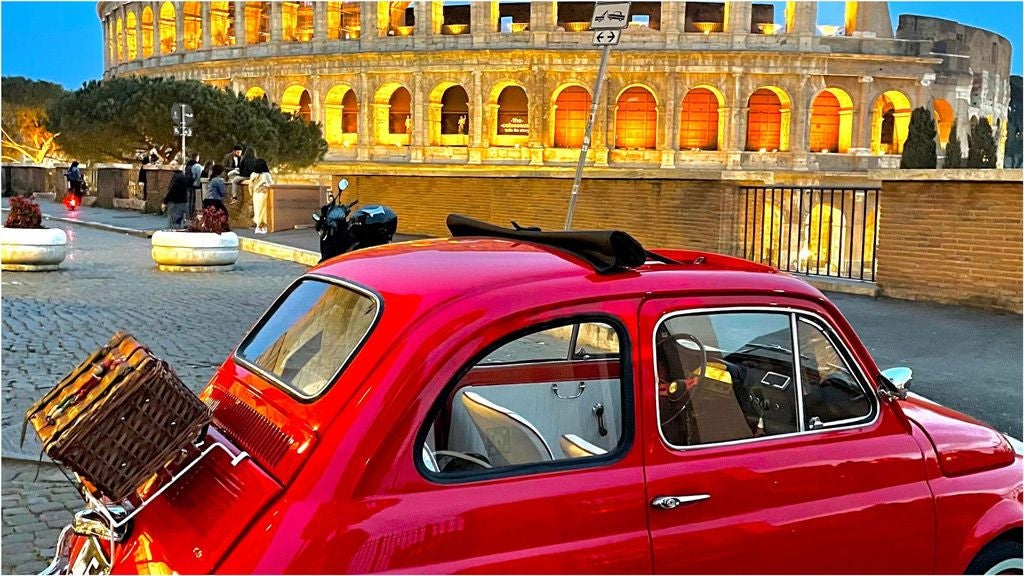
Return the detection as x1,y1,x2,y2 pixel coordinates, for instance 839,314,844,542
646,297,882,451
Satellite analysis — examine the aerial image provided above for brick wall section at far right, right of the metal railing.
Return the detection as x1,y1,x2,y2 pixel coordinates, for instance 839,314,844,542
878,179,1024,313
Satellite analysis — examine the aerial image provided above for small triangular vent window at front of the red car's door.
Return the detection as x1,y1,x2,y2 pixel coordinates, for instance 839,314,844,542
797,318,871,429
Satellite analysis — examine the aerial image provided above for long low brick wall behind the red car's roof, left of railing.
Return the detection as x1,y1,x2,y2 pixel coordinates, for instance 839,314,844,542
334,175,742,253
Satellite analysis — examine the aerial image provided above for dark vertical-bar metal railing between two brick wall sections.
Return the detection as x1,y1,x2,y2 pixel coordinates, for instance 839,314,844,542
740,187,880,282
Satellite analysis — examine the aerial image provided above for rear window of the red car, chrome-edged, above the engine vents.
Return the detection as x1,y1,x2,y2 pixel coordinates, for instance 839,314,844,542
237,278,380,399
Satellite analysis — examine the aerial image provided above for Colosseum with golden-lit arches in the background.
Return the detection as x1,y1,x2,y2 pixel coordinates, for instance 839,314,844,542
98,0,1011,173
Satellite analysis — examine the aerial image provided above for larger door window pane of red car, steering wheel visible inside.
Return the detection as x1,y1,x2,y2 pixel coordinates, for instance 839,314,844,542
654,312,799,447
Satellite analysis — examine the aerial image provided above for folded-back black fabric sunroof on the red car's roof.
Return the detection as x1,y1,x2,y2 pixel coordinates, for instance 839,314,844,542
446,214,648,274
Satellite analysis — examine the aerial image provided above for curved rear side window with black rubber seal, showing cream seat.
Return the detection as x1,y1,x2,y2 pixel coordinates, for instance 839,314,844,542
416,322,626,478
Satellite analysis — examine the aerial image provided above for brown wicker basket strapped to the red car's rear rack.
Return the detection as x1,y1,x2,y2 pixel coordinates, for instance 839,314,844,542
27,333,210,501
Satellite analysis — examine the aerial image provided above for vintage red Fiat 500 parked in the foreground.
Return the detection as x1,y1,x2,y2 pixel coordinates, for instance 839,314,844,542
51,218,1024,574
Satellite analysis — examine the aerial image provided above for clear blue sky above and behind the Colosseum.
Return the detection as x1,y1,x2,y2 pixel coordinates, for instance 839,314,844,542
0,0,1024,89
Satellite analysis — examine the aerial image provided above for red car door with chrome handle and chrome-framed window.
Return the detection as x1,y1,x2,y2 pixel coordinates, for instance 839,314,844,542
640,298,934,574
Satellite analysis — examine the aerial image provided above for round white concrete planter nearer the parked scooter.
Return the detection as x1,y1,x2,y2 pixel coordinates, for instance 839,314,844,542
153,230,239,272
